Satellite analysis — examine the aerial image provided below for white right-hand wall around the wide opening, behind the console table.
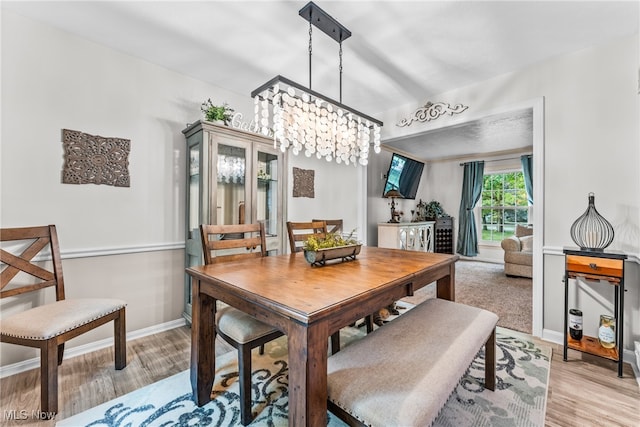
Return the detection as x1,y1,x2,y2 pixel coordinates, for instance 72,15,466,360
370,35,640,349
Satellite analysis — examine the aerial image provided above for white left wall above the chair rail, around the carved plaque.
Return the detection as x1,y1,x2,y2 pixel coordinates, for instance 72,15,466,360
2,11,255,250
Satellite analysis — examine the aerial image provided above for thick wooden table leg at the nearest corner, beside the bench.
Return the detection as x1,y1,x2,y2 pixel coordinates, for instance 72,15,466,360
287,321,329,427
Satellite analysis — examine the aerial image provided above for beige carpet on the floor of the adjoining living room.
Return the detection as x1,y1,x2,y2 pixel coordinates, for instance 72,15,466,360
403,260,533,334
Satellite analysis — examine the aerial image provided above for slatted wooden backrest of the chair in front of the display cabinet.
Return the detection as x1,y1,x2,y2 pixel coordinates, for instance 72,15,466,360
200,222,267,264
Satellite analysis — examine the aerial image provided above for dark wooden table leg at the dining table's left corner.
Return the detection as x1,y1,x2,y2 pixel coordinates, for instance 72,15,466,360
191,279,216,406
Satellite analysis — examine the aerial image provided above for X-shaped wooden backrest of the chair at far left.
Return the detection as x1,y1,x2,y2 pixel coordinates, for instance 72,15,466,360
0,225,64,300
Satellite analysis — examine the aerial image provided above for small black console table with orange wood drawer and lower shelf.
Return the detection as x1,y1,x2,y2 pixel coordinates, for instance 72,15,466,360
562,248,627,377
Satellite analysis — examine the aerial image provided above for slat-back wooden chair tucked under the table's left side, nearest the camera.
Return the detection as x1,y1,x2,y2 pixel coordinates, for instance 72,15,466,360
200,222,283,426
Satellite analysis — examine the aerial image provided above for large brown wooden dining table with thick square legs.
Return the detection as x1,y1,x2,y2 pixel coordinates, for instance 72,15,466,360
187,246,459,427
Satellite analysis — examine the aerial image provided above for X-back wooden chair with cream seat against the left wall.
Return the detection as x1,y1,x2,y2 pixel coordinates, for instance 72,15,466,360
0,225,127,418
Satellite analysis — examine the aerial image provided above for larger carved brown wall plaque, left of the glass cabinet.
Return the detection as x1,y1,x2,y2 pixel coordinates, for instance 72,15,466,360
62,129,131,187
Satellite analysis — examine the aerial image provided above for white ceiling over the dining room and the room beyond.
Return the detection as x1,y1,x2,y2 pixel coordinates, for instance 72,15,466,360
1,0,640,159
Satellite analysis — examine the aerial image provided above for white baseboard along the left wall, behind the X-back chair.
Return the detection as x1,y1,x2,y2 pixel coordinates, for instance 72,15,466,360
0,318,187,378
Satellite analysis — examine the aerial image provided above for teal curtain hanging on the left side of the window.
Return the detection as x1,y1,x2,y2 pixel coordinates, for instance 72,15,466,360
457,162,484,256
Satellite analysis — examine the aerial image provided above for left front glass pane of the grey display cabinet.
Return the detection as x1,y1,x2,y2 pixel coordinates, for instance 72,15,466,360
216,144,245,225
